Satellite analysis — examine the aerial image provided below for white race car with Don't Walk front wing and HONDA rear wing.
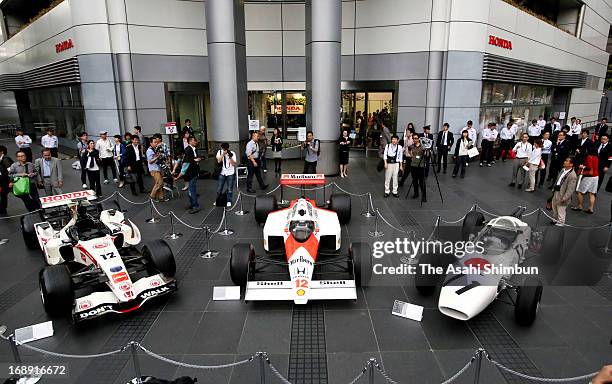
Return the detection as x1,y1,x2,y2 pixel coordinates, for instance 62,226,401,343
21,190,177,323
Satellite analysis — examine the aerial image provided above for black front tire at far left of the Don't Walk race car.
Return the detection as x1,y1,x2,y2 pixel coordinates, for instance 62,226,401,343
39,265,74,316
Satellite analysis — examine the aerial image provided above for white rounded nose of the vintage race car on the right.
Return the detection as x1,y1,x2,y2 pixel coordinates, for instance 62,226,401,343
438,285,497,321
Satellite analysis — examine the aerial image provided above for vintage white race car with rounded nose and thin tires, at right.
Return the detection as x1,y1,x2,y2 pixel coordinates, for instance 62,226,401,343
415,209,557,326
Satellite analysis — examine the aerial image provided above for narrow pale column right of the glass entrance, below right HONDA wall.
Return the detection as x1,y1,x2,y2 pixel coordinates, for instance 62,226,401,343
428,0,452,132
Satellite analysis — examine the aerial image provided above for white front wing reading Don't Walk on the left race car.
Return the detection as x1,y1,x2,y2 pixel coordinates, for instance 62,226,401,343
72,274,178,324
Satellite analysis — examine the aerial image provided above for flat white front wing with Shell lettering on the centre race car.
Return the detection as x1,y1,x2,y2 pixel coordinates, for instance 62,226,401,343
244,280,357,304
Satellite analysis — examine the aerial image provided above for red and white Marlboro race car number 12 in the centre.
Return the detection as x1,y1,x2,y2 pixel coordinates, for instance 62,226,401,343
230,175,372,304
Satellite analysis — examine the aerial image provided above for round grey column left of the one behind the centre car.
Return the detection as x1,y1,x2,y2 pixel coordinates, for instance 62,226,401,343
206,0,249,150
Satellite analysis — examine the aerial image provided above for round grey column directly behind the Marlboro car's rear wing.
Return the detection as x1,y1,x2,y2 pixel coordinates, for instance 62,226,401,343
306,0,342,175
